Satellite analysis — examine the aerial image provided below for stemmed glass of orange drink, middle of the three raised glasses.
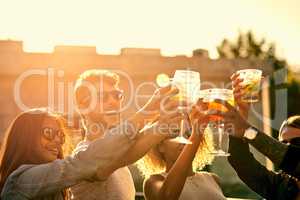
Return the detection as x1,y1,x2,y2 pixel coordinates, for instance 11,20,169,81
198,88,234,156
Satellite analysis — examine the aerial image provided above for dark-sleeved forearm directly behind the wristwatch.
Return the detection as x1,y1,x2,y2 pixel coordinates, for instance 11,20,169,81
249,129,288,165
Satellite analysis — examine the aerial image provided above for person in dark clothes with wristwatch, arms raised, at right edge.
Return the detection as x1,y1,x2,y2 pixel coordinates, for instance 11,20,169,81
205,75,300,200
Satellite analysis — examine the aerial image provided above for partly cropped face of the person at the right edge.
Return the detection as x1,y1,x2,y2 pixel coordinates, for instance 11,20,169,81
279,126,300,146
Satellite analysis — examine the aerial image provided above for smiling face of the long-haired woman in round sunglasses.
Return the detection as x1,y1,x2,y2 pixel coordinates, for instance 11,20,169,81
35,117,64,162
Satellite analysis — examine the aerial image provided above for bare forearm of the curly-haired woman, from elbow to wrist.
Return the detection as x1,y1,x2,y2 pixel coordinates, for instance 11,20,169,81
159,133,200,199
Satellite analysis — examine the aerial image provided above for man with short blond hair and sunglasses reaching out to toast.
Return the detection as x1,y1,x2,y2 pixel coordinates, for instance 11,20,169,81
71,70,182,200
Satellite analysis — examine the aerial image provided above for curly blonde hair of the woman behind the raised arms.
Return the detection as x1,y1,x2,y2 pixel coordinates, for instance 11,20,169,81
136,133,214,178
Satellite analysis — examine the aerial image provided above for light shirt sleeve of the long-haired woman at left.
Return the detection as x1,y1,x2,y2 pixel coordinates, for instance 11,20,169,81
1,119,136,199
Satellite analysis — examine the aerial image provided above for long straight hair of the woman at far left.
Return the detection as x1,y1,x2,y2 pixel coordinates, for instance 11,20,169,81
0,108,66,198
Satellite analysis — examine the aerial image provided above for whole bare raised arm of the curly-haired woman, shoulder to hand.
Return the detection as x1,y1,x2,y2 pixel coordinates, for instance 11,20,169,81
144,102,208,200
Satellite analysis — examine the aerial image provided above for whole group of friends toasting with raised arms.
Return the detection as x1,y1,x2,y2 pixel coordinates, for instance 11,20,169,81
0,70,300,200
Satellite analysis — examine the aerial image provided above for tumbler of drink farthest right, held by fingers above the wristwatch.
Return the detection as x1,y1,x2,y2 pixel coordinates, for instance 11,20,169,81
237,69,262,103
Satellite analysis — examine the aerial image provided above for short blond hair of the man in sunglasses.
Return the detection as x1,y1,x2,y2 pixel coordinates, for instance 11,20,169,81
74,69,120,106
